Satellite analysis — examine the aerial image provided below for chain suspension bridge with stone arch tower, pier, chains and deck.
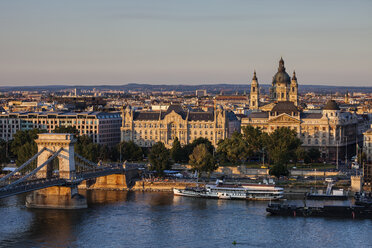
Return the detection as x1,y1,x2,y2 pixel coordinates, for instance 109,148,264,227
0,133,138,208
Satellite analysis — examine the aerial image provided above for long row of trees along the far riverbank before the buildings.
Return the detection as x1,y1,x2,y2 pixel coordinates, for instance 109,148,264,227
0,126,326,177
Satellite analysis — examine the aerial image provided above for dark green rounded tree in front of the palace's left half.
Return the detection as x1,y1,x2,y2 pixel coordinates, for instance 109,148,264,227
149,142,171,176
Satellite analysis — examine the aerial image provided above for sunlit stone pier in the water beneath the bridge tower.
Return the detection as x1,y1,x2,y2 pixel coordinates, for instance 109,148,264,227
26,186,88,209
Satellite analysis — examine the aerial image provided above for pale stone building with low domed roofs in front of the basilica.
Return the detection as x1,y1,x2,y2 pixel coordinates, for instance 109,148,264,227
242,100,358,160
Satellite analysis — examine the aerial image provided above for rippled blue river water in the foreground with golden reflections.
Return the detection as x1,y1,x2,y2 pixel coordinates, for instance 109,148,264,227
0,191,372,248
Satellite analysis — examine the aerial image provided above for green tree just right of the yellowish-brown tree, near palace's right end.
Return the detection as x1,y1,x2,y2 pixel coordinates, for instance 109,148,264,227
217,132,248,163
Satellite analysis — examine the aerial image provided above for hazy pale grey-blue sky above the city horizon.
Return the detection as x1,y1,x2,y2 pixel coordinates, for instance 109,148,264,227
0,0,372,86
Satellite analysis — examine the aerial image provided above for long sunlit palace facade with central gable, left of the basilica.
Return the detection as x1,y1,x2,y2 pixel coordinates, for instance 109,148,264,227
121,105,240,148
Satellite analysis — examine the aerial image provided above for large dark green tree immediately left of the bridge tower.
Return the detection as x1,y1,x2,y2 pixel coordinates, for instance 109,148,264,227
10,129,44,166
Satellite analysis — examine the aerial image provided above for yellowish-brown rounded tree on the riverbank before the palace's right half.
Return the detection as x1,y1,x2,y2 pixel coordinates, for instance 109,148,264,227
190,144,218,175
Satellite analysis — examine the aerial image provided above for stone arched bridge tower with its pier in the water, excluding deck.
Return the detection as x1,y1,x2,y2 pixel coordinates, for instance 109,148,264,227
26,133,87,209
